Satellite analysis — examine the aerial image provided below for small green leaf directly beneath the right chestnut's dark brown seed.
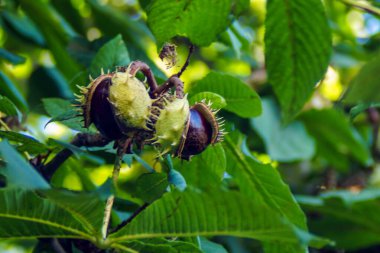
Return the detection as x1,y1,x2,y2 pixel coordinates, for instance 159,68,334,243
175,144,226,190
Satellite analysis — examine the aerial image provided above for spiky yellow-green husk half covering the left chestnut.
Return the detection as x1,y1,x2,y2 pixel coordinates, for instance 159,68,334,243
109,72,152,129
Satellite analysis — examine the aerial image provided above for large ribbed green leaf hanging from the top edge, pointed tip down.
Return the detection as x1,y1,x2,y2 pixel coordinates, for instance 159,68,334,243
265,0,331,121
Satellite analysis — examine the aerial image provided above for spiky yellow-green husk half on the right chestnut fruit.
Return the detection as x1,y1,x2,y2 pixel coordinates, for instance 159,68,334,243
154,96,190,155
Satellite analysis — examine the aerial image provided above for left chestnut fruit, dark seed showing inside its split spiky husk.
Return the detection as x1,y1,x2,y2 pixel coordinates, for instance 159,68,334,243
77,68,152,139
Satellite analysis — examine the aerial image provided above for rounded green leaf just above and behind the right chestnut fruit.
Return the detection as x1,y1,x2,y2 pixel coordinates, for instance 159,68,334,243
190,72,261,118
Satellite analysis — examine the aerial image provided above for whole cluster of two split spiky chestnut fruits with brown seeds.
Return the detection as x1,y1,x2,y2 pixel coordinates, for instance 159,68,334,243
78,61,223,160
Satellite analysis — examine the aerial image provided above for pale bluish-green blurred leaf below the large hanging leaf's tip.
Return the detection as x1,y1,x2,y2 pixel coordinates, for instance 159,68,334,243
251,99,315,162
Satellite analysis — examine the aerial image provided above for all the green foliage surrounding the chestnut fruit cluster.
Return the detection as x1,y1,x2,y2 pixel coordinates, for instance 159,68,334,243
0,0,380,253
